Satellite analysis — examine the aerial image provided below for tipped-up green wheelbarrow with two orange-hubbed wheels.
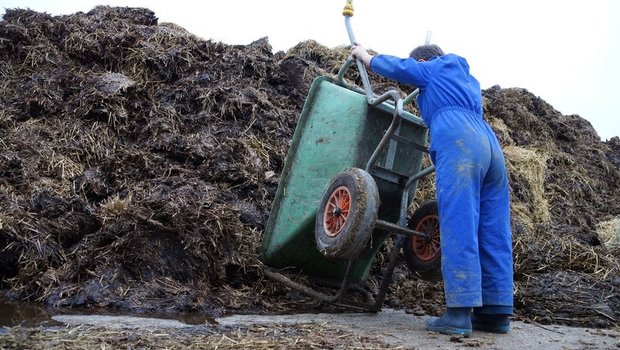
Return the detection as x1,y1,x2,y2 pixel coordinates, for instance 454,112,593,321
261,1,441,312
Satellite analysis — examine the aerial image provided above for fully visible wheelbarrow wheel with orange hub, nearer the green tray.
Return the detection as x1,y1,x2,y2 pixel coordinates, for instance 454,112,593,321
315,168,379,259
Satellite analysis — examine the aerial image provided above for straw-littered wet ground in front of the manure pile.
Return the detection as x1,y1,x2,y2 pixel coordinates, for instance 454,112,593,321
0,309,620,350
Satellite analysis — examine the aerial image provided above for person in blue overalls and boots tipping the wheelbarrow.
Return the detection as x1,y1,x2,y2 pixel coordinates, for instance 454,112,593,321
352,45,513,336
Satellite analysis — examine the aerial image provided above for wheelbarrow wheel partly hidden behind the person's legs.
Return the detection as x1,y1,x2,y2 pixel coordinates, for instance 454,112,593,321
404,201,441,281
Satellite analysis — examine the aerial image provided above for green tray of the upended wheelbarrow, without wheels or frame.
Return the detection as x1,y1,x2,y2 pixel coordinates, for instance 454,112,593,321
261,76,427,283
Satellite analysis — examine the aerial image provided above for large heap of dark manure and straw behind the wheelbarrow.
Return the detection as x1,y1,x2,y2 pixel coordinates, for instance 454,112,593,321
0,7,620,327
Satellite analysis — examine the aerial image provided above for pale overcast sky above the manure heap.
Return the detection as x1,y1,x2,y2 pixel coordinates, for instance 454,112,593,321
0,0,620,140
